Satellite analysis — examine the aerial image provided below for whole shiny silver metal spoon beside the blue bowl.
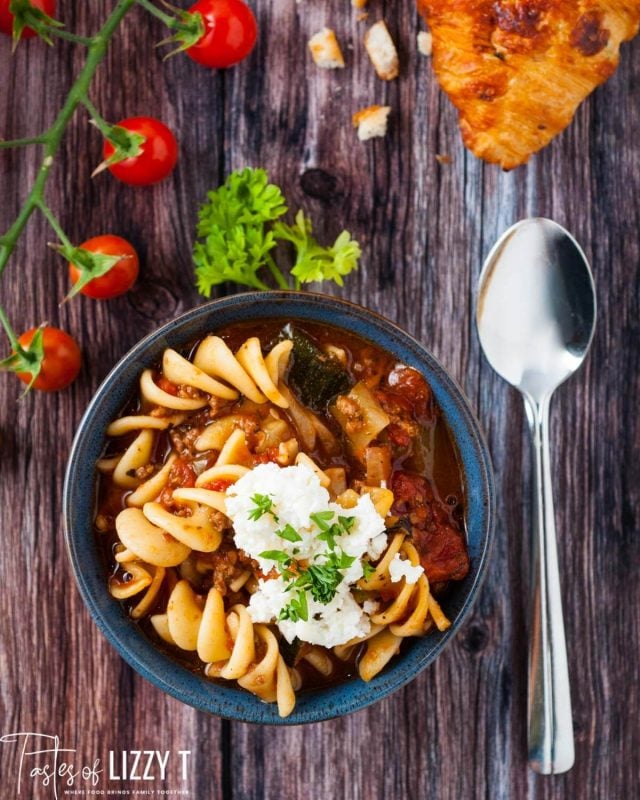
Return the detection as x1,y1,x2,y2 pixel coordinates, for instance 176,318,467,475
476,219,596,775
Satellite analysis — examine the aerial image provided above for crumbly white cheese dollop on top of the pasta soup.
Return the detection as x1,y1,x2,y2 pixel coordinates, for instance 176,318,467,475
226,463,387,647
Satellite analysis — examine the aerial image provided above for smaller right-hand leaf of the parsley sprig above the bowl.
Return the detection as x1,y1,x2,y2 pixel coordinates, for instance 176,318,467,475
273,211,362,288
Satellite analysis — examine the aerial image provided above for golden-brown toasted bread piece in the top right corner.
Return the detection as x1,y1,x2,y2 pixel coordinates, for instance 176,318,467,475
418,0,640,169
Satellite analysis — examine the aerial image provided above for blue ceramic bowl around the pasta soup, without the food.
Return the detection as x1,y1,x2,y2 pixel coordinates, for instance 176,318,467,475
63,292,495,725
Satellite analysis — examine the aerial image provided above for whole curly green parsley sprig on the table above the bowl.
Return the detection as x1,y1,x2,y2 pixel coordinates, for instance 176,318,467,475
193,167,361,297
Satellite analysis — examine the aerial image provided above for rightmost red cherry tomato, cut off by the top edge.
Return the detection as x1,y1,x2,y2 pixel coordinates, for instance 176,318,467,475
186,0,258,69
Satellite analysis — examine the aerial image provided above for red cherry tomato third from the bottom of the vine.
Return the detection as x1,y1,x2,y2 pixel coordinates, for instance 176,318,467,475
103,117,178,186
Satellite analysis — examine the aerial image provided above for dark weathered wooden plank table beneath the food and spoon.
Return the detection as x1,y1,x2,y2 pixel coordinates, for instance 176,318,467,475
0,0,640,800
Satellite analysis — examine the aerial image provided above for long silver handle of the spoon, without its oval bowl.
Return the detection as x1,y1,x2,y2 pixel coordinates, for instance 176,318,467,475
525,395,574,775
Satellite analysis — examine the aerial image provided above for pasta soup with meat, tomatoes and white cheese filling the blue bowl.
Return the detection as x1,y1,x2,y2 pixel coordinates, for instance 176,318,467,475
96,323,468,716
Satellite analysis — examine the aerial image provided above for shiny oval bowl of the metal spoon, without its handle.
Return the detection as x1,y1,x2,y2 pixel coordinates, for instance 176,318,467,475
477,218,596,401
